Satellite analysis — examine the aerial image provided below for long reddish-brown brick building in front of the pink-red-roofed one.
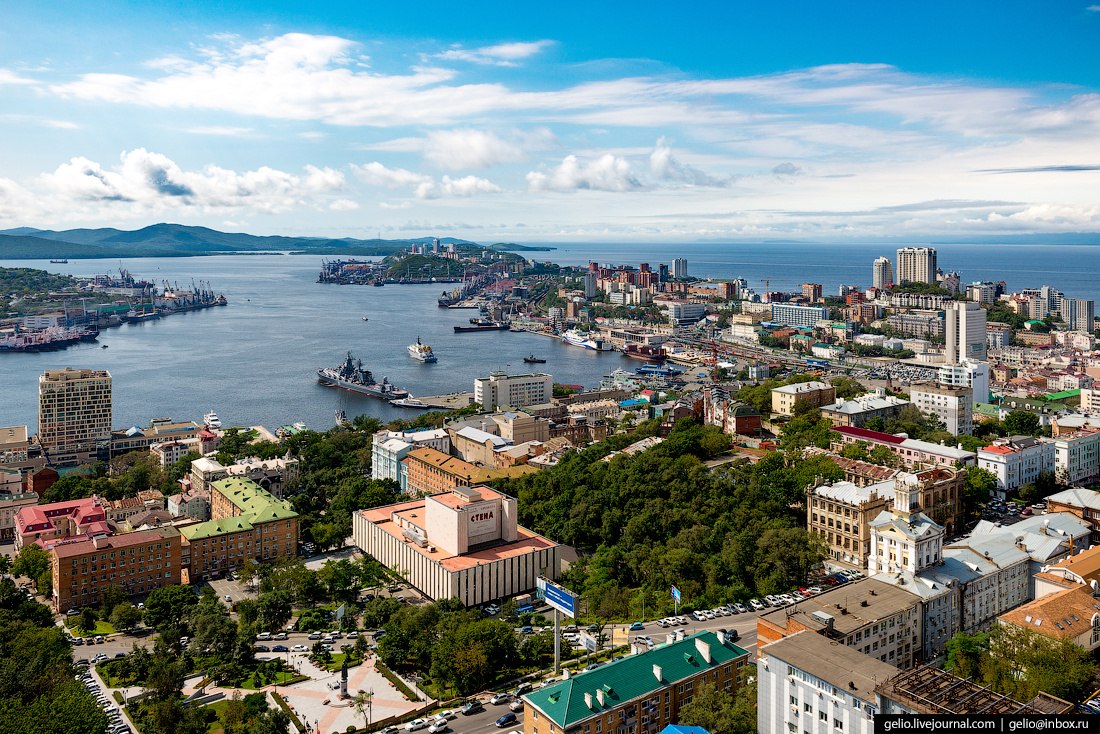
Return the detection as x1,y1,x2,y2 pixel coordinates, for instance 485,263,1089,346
50,527,182,612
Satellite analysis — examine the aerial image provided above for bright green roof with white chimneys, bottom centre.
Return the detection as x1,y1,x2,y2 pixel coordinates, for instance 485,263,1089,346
524,632,749,728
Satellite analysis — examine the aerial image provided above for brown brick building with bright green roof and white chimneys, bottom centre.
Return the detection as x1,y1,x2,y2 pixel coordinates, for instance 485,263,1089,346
524,631,749,734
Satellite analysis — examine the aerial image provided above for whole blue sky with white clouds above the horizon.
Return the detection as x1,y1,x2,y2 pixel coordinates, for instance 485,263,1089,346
0,0,1100,241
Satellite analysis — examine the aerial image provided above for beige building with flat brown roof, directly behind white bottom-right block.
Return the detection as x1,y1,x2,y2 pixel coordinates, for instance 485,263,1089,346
757,579,922,669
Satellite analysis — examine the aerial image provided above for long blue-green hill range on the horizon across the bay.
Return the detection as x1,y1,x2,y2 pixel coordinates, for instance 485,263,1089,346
0,223,503,260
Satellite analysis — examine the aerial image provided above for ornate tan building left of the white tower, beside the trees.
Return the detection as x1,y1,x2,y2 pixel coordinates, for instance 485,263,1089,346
806,480,894,571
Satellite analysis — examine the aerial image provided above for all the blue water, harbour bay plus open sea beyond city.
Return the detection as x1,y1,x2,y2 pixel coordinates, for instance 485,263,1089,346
0,242,1100,430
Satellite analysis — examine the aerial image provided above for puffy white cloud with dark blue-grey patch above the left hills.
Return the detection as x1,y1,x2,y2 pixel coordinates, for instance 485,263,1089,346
25,147,344,213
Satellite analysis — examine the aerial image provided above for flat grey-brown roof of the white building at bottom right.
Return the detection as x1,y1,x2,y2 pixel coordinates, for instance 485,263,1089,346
760,629,899,702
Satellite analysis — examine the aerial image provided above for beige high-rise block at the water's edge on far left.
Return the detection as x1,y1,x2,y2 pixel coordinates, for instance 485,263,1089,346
39,368,111,465
